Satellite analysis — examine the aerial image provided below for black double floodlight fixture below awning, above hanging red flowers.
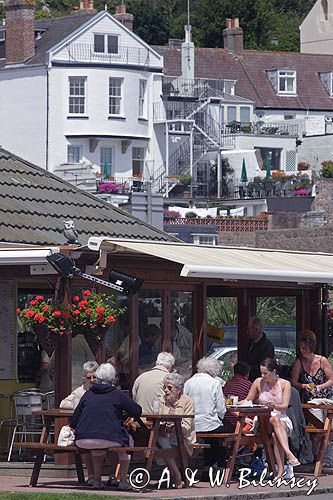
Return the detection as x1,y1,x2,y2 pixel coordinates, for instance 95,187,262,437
46,253,143,294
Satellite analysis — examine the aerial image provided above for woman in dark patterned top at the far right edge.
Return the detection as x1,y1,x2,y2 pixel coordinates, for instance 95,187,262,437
290,330,333,403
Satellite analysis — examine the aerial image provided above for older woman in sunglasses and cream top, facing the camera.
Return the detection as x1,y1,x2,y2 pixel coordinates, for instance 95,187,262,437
157,373,196,488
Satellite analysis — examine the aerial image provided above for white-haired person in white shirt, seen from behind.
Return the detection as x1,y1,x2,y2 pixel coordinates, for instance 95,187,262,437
184,357,226,467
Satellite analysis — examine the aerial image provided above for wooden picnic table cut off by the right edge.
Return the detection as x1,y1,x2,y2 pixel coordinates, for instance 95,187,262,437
302,401,333,477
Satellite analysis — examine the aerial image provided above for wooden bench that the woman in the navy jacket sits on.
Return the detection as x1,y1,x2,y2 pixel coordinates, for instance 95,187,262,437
13,442,156,487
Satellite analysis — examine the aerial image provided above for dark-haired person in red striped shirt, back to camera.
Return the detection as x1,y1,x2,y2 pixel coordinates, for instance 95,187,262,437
223,361,252,431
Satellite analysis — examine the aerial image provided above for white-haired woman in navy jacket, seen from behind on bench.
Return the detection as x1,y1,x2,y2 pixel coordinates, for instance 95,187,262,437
71,363,142,490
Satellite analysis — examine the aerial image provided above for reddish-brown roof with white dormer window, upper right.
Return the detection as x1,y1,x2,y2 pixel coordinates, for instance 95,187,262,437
154,46,333,111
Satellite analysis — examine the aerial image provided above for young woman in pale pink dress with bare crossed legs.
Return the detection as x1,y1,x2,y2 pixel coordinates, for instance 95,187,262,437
246,358,300,477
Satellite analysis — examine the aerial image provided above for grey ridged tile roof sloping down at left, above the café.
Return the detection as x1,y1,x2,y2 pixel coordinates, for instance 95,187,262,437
0,148,177,245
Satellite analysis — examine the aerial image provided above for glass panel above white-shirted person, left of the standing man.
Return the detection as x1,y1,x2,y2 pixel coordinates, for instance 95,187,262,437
207,297,238,380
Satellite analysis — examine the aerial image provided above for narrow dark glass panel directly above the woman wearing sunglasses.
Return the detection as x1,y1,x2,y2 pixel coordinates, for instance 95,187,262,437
170,291,193,379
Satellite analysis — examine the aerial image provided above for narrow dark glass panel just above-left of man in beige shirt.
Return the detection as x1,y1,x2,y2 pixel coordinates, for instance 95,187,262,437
138,290,162,373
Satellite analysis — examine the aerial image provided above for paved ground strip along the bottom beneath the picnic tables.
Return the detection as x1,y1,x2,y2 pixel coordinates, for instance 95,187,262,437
0,466,333,500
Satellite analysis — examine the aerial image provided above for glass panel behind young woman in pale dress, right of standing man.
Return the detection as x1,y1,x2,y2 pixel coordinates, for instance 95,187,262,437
255,297,296,374
